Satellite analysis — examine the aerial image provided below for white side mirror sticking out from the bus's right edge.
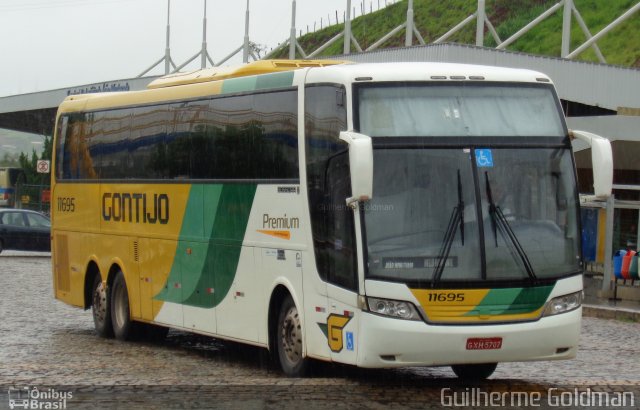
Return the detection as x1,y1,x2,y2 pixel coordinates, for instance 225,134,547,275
569,130,613,199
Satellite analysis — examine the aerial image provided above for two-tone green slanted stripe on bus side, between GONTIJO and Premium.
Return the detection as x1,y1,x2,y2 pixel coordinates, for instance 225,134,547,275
156,184,257,308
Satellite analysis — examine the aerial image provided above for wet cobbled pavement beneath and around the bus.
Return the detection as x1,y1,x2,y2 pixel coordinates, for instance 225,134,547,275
0,252,640,409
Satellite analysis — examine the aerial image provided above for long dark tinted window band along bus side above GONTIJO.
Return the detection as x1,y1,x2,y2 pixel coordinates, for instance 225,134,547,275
57,90,299,180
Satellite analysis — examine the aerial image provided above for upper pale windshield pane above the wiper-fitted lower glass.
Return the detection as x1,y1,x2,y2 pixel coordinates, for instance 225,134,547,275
357,82,564,137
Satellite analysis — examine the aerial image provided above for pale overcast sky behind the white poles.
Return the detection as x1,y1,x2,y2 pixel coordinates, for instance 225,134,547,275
0,0,394,97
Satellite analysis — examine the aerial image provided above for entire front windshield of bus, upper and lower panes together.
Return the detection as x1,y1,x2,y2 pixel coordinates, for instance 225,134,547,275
359,86,580,286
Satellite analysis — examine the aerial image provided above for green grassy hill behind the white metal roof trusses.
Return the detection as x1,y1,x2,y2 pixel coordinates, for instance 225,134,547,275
270,0,640,67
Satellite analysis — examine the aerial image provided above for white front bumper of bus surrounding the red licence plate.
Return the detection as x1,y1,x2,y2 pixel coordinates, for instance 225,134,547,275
357,308,582,367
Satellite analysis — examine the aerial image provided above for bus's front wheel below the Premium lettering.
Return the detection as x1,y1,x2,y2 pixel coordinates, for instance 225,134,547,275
276,295,309,377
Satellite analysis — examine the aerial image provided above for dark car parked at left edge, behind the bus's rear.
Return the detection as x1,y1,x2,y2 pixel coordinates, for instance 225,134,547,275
0,209,51,252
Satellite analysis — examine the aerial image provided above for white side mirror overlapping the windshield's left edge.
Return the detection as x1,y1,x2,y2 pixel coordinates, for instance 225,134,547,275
340,131,373,206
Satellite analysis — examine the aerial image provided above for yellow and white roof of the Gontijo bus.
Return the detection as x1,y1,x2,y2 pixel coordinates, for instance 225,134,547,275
58,60,551,114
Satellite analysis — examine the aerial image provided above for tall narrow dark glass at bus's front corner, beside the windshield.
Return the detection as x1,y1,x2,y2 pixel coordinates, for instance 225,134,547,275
305,86,357,289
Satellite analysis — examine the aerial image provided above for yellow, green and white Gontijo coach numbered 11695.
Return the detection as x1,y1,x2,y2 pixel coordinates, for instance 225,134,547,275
51,60,612,379
